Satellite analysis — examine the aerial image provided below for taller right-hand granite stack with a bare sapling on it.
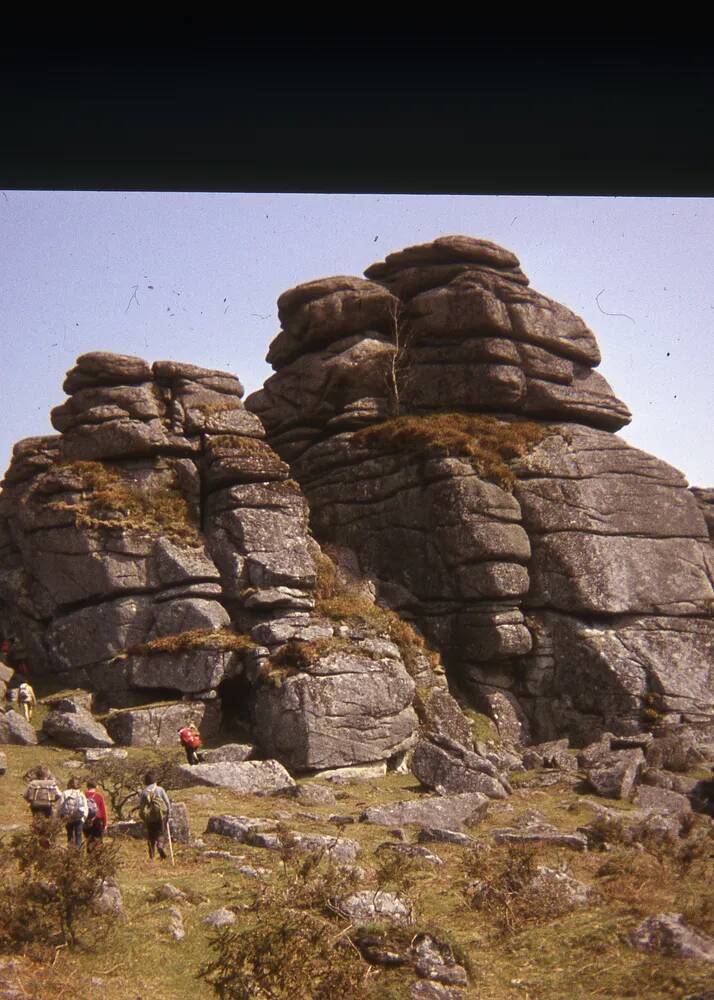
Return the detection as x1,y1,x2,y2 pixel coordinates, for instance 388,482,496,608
246,236,714,743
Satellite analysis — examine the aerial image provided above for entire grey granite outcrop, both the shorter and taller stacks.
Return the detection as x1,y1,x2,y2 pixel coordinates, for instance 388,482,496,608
0,236,714,756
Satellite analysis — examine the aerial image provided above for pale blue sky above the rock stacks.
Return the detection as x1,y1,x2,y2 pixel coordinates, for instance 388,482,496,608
0,191,714,486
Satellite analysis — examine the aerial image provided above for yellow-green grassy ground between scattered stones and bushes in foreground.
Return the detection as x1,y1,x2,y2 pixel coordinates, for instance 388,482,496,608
0,746,714,1000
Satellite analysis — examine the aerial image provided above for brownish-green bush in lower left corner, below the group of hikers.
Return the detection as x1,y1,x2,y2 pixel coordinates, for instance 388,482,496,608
0,820,118,957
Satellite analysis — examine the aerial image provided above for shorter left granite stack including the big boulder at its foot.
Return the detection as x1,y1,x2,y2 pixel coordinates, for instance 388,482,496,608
0,353,442,768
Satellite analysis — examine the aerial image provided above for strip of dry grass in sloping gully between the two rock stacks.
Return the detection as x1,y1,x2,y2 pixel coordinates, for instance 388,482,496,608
315,553,443,676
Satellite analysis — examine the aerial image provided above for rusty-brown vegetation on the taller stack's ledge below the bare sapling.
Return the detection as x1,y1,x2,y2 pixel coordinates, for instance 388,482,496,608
352,413,549,490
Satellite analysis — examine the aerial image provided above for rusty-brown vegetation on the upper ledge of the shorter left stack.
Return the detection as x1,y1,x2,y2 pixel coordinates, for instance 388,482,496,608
49,462,201,547
